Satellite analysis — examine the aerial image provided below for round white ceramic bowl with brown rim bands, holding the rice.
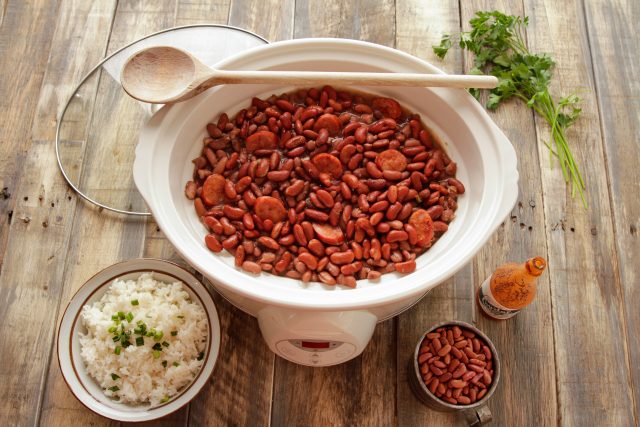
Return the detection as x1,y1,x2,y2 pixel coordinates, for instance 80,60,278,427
58,259,220,422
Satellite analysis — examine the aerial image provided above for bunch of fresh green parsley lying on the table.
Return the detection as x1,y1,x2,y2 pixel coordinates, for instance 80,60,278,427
433,10,587,207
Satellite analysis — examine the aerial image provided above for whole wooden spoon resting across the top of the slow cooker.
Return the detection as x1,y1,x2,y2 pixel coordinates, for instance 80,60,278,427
120,46,498,104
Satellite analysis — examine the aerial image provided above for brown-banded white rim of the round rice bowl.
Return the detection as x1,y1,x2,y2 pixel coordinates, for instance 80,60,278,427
56,258,222,423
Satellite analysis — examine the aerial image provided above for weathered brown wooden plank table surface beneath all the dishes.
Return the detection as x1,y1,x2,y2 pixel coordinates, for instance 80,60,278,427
0,0,640,426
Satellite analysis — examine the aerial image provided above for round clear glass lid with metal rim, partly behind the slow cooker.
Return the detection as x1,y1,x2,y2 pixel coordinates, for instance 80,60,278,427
56,25,268,215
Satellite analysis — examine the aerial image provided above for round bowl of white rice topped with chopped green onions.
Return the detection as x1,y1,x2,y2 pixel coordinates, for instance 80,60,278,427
58,259,220,422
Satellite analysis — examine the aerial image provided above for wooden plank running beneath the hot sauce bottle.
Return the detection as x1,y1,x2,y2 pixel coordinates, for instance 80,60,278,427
461,1,557,425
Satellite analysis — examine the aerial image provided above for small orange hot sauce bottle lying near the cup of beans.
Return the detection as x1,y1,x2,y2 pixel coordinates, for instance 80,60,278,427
478,257,547,320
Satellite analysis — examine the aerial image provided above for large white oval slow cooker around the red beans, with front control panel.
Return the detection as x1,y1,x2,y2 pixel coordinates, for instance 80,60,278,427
134,39,518,366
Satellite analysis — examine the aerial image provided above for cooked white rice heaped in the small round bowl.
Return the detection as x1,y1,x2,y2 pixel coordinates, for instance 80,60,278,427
80,273,208,405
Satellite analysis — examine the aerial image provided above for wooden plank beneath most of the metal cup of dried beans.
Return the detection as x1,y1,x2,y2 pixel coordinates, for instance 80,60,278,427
396,0,473,426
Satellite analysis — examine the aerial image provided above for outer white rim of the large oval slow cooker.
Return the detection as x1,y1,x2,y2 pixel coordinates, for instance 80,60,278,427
134,38,518,311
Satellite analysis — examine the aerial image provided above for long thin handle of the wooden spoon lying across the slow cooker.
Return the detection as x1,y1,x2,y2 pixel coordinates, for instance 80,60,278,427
211,70,498,89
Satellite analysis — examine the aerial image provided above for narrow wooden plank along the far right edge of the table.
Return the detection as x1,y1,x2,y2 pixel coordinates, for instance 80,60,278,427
584,1,640,423
